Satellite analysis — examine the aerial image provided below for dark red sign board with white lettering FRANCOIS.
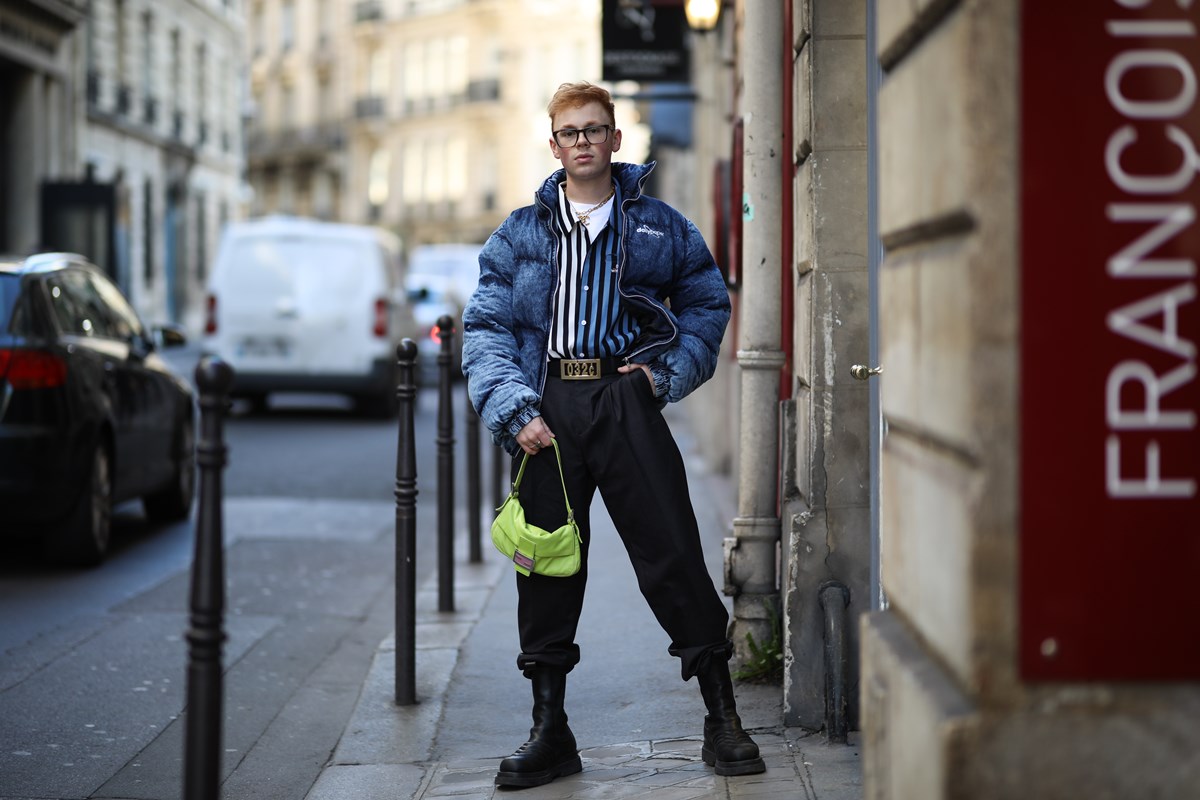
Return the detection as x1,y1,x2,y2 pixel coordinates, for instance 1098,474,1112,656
1019,0,1200,681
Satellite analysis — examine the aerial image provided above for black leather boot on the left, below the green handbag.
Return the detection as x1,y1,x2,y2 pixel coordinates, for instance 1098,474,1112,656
496,668,583,788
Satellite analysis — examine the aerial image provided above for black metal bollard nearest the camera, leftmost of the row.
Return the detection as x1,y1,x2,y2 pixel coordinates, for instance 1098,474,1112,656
184,356,233,800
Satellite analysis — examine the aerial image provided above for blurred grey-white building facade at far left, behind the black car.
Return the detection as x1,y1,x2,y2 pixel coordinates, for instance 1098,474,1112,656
0,0,244,332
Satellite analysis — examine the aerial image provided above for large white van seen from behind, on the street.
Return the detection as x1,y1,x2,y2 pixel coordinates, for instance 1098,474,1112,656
204,217,419,415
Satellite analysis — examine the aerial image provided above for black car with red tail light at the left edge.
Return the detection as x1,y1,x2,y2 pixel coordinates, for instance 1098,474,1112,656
0,253,196,565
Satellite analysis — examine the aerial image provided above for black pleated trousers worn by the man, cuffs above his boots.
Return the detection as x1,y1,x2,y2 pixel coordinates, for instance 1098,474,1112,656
512,369,732,680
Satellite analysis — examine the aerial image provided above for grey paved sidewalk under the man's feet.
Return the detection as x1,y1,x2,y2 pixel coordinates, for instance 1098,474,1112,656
306,415,862,800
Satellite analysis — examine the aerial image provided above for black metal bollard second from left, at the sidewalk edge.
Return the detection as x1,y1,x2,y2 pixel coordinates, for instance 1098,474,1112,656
396,339,416,705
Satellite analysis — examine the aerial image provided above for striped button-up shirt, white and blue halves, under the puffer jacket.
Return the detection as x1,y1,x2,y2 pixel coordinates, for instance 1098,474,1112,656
550,182,637,359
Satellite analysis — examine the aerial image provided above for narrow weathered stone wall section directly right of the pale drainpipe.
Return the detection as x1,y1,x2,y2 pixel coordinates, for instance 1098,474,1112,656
781,0,871,728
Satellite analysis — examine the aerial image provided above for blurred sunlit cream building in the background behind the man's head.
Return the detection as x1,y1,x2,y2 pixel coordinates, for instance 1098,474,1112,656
238,0,647,253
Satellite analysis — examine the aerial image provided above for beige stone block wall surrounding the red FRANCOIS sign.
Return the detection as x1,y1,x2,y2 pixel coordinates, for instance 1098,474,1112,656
862,0,1200,800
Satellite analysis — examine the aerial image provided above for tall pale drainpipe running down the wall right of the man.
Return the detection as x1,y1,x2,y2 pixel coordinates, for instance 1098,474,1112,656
725,2,787,663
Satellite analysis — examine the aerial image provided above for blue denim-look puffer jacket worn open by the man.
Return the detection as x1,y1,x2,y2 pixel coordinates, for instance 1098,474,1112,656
462,163,730,455
